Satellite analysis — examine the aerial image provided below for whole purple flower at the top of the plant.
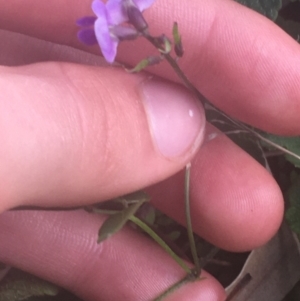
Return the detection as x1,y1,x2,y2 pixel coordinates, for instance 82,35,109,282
77,0,154,63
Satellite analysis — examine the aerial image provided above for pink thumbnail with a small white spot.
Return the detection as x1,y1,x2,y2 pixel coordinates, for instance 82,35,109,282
142,79,205,158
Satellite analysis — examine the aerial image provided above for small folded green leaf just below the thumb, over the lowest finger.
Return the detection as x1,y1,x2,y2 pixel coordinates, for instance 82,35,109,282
98,192,149,243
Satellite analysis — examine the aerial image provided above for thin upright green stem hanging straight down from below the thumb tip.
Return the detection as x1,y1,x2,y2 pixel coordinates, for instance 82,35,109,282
184,163,201,276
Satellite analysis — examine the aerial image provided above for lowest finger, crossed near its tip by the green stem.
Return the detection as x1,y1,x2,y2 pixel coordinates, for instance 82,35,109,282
0,211,225,301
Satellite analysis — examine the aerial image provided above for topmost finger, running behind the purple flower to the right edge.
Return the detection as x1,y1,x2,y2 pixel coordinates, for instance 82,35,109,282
0,0,300,134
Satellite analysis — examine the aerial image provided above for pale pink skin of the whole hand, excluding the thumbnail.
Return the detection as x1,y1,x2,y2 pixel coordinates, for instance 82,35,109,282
0,0,300,301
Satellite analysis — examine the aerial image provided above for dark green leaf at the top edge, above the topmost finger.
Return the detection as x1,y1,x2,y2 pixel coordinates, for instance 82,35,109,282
236,0,282,20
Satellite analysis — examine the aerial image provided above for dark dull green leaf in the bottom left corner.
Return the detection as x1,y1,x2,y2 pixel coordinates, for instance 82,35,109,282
0,269,59,301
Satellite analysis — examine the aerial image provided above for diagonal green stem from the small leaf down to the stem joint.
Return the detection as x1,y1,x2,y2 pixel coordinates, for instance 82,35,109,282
129,216,192,275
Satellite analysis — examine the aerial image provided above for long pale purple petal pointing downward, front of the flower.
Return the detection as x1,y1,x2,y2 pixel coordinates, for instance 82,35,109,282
95,18,119,63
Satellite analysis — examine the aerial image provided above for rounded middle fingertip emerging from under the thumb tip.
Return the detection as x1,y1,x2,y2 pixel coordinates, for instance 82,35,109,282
149,126,284,251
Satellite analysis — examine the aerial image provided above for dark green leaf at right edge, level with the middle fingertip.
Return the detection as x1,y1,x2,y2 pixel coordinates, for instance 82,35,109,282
285,175,300,235
